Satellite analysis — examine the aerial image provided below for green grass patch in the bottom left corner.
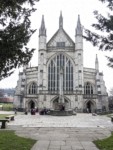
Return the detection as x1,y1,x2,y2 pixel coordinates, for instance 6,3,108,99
0,130,36,150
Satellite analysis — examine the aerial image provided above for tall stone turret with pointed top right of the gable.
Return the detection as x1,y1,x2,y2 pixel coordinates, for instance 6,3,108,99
75,15,84,91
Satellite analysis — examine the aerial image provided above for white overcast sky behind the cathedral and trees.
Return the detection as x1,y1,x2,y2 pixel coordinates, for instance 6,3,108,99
0,0,113,93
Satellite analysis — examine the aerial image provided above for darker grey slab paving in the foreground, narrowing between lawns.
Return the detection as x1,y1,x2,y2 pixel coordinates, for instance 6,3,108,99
10,126,111,150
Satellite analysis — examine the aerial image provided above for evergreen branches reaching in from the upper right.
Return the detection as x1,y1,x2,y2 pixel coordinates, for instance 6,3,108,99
84,0,113,67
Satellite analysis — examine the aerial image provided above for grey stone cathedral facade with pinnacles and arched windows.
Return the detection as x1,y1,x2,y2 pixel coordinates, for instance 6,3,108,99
14,13,108,112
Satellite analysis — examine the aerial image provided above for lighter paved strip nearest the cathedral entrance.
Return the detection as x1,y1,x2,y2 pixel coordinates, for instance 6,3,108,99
9,113,112,128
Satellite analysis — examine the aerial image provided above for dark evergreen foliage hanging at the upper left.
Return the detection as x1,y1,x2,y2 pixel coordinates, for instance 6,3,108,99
0,0,39,80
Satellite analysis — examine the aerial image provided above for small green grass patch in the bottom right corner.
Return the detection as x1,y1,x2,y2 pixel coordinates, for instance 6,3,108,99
94,133,113,150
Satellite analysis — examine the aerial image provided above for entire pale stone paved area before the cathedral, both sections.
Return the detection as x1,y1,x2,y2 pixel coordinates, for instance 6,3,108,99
0,111,113,150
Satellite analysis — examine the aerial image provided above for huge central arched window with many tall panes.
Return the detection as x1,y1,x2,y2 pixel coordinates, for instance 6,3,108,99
48,54,73,91
